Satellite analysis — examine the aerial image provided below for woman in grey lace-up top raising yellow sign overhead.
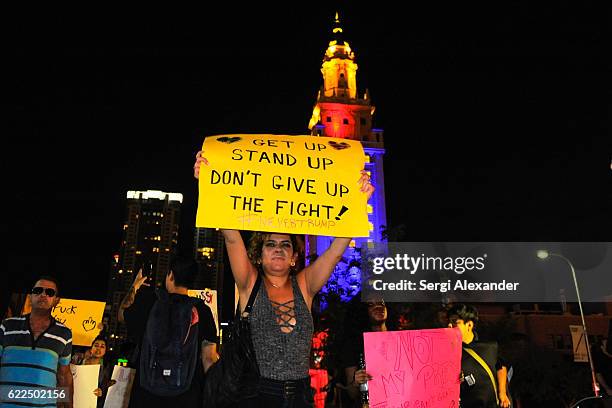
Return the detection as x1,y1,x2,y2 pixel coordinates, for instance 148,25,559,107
194,152,374,408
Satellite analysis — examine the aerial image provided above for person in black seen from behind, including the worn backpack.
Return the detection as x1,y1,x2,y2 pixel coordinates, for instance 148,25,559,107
120,258,219,408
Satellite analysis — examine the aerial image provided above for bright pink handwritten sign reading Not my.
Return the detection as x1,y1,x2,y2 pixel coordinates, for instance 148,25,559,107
363,329,461,408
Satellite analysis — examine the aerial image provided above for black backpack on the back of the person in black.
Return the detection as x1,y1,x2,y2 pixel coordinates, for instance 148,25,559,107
140,290,200,397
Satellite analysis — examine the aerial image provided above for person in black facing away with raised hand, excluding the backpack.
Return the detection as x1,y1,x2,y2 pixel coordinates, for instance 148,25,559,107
119,258,219,408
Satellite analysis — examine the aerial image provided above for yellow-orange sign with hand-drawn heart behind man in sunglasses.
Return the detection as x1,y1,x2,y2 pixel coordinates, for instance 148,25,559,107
23,296,106,346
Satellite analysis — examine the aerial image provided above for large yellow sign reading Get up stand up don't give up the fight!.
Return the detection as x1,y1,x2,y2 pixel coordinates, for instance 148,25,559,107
196,135,369,237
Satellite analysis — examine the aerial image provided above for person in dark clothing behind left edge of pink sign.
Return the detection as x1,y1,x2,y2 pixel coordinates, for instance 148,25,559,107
340,295,390,407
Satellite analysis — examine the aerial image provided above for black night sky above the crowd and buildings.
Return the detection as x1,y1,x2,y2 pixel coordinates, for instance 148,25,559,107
1,2,612,299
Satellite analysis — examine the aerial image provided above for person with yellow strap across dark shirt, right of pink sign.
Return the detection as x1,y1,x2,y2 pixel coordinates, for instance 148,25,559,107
447,304,510,408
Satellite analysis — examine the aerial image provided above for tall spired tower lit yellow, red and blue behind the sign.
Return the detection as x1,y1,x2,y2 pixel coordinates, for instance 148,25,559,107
307,13,387,254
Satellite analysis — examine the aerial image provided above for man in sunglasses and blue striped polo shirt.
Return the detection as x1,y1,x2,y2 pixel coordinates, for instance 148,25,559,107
0,276,73,408
